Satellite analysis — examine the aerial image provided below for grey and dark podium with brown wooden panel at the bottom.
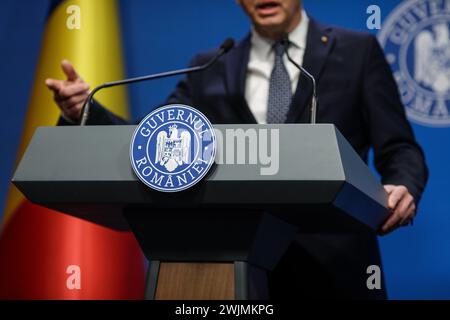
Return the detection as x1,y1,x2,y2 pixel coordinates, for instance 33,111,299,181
12,124,388,299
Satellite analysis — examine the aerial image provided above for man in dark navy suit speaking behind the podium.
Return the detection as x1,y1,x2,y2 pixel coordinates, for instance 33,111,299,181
46,0,428,299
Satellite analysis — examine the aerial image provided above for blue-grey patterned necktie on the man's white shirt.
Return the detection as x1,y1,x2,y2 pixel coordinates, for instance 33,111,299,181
267,42,292,123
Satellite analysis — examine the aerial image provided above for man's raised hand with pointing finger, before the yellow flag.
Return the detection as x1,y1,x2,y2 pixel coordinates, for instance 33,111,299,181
45,60,89,122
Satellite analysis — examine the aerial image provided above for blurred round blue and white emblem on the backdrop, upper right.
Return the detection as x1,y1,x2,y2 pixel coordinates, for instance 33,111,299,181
378,0,450,127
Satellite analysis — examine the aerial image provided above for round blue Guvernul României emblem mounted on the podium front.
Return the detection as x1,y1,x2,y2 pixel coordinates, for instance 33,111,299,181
130,104,216,192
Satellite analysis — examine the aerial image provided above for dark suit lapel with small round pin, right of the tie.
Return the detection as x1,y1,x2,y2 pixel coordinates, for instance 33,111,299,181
286,19,335,123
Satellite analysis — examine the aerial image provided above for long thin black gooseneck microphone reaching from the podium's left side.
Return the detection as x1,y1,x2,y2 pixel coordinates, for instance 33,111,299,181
80,38,234,126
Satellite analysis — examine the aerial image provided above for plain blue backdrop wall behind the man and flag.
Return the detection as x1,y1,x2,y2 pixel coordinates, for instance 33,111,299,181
0,0,450,299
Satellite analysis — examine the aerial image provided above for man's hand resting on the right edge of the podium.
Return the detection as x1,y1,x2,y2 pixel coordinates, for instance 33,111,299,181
380,184,416,235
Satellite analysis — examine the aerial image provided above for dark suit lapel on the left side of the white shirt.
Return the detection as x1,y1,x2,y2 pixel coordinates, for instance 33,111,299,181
225,34,256,123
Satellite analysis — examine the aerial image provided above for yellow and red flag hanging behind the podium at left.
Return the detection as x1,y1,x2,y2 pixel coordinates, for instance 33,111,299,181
0,0,145,299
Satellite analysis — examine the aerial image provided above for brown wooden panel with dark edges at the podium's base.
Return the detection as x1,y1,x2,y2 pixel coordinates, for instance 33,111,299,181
145,261,267,300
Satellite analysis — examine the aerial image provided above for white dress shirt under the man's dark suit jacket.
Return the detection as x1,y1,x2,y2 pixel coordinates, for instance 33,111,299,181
245,10,309,124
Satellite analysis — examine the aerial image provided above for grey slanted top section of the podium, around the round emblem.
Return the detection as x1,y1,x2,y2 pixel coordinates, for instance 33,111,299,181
12,124,386,231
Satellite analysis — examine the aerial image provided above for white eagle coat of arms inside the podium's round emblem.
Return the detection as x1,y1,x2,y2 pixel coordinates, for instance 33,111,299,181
155,124,191,172
